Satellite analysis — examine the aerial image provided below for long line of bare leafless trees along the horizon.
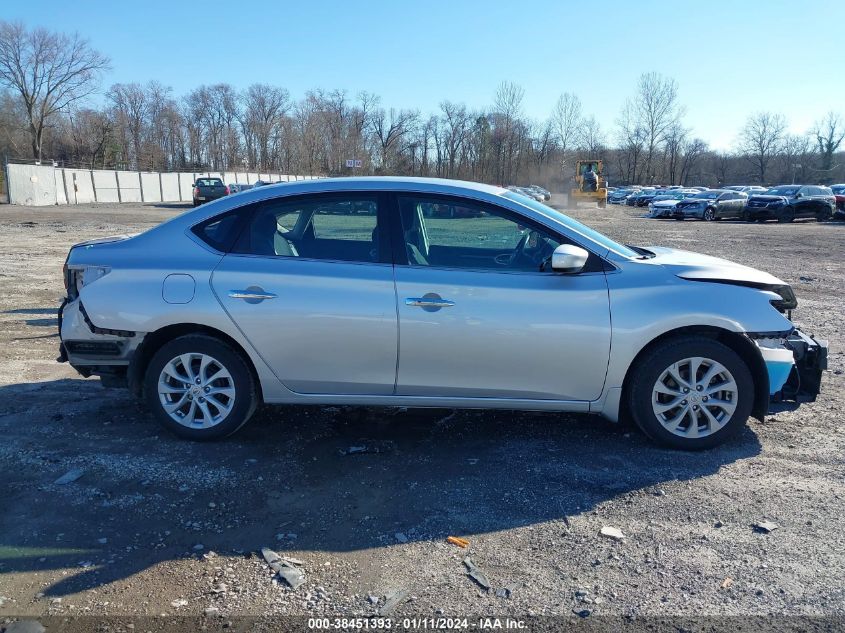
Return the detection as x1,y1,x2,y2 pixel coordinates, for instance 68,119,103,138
0,21,845,189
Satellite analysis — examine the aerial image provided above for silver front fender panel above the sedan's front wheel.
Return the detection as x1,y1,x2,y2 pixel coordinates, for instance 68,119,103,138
591,260,793,420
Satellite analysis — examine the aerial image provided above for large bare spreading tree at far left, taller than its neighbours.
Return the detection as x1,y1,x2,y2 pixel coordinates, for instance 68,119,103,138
0,21,109,160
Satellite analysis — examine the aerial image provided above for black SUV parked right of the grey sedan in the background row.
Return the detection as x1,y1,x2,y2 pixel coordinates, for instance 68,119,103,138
745,185,836,222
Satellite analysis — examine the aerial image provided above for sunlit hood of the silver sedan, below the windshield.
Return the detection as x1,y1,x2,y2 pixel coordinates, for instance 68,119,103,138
647,246,786,288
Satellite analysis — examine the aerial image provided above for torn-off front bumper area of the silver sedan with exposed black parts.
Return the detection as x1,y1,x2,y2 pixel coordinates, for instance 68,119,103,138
754,329,828,402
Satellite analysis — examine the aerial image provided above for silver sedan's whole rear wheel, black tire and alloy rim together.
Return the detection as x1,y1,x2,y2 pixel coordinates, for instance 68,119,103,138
144,334,258,440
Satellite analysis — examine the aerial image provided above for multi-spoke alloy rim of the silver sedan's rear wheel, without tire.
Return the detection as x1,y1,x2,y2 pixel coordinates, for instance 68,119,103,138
158,354,235,429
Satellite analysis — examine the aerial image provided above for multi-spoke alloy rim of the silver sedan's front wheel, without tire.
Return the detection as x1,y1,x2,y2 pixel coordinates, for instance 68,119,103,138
651,356,739,438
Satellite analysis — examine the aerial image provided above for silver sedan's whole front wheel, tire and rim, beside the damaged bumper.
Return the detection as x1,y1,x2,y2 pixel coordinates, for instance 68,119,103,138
626,336,754,450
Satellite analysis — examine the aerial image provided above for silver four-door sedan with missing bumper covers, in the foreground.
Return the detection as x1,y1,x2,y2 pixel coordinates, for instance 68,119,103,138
60,178,827,449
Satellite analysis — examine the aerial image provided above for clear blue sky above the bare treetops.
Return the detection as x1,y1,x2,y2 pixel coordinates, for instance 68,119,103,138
6,0,845,148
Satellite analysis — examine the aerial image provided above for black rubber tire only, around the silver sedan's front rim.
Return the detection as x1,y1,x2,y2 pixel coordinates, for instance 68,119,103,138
623,336,754,450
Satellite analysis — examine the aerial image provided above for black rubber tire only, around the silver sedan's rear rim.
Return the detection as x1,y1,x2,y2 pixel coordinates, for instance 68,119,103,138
144,334,259,441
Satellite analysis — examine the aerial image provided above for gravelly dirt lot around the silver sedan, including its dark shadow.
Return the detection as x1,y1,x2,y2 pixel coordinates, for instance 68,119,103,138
0,200,845,616
